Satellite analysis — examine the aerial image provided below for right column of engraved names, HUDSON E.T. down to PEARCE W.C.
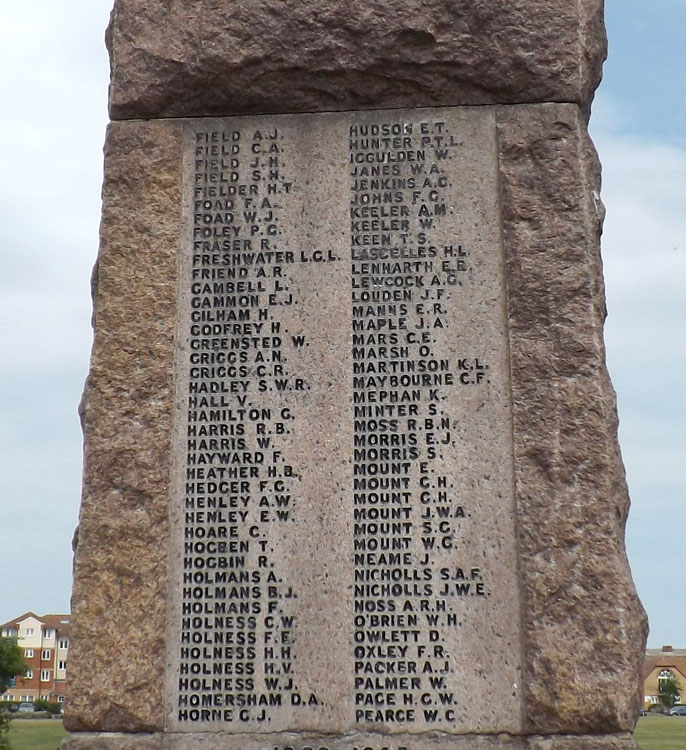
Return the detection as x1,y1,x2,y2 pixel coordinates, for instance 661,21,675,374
349,120,492,726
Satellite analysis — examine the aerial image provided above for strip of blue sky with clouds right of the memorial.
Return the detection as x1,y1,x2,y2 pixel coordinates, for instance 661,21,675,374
591,0,686,648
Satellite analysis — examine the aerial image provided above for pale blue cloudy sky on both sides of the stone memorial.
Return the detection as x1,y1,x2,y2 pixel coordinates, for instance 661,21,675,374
0,0,686,647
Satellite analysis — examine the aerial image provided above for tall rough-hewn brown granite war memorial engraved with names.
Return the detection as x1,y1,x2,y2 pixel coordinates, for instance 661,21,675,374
63,0,645,750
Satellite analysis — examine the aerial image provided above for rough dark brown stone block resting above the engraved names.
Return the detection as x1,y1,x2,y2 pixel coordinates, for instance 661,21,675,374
107,0,606,120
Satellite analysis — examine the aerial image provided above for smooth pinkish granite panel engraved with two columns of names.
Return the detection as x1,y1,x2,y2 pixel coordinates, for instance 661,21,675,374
166,107,521,735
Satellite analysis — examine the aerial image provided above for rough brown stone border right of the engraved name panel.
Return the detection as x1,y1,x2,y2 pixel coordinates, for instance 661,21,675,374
497,104,647,736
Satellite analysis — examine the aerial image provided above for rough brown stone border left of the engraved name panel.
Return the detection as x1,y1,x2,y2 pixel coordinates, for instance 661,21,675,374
65,122,181,732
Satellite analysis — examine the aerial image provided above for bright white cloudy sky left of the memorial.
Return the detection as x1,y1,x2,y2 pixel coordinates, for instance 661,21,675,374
0,0,112,621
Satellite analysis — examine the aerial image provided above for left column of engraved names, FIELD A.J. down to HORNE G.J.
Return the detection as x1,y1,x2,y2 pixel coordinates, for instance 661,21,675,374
177,127,304,726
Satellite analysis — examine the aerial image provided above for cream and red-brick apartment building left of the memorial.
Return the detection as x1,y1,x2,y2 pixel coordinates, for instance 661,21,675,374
0,612,71,703
